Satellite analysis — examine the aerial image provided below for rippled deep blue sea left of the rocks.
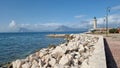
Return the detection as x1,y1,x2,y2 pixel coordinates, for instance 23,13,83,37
0,31,85,65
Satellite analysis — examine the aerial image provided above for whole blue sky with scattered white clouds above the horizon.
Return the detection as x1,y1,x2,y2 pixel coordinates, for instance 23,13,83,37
0,0,120,32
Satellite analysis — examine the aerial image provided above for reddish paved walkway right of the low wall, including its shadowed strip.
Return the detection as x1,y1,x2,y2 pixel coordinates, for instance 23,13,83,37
105,34,120,68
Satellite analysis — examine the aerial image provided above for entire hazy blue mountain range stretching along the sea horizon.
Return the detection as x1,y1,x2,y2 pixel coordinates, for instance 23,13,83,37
18,25,86,32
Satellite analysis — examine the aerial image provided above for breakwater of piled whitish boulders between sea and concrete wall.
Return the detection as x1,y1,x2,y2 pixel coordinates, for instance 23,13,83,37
10,34,99,68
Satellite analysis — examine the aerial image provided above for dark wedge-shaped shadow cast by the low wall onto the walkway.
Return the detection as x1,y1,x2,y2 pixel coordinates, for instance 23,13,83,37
104,39,118,68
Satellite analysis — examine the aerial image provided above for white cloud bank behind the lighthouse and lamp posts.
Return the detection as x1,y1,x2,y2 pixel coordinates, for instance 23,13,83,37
89,13,120,28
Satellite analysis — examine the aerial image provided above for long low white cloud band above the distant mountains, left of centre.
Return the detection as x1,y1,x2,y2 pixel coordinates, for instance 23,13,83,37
17,22,62,31
